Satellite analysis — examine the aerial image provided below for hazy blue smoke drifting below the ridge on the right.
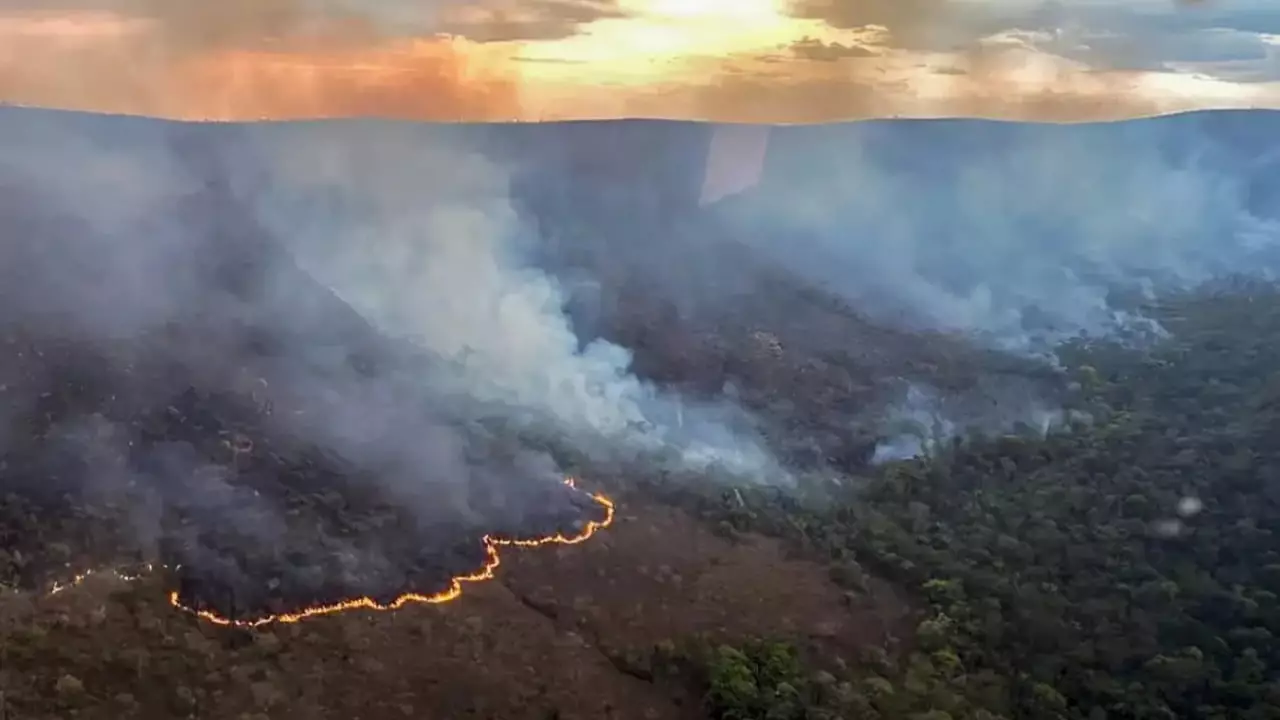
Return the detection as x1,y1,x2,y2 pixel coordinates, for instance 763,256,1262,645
717,114,1280,354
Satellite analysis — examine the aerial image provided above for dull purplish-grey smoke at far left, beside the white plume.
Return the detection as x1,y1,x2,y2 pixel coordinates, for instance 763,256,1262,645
0,110,517,600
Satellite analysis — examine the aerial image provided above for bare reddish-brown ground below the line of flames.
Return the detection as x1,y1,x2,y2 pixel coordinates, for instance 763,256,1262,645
0,491,911,720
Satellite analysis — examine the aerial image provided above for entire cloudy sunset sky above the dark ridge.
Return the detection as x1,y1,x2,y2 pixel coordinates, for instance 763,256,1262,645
0,0,1280,123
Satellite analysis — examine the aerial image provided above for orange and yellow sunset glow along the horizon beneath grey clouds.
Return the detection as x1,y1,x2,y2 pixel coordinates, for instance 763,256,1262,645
0,0,1280,123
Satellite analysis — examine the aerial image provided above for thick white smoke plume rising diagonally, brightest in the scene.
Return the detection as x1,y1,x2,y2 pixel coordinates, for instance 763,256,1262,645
236,123,781,478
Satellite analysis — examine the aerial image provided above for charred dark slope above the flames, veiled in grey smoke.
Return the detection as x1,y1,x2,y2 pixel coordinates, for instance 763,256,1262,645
0,158,603,618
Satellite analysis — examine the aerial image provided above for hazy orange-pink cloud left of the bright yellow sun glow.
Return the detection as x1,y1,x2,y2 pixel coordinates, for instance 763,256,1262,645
0,0,634,120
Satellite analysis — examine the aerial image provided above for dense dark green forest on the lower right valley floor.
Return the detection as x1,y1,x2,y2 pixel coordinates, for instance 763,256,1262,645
660,282,1280,720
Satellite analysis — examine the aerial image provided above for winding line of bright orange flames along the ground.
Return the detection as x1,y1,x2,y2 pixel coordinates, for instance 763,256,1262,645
49,478,614,628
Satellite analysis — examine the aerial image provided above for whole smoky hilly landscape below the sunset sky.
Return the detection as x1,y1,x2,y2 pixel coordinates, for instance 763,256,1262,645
0,110,1280,720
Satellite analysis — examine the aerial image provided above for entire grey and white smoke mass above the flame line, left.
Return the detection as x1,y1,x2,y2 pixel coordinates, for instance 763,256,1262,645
0,109,773,604
